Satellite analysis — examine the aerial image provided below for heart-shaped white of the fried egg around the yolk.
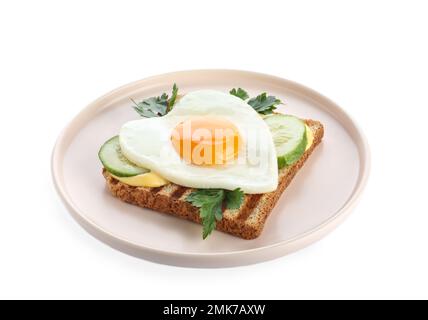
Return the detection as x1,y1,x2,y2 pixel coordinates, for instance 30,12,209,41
119,90,278,193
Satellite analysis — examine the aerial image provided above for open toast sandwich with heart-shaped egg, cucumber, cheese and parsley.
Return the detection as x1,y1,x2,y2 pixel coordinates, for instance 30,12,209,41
98,84,324,239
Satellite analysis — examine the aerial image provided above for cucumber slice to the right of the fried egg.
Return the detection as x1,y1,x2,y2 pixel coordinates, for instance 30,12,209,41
264,114,307,169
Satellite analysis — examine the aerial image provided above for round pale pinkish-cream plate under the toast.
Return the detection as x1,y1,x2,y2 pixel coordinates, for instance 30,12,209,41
52,70,369,267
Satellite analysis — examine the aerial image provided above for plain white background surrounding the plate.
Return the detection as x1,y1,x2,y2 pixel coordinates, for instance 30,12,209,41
0,0,428,299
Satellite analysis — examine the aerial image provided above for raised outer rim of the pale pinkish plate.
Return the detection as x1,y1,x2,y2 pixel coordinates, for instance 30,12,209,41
51,69,371,267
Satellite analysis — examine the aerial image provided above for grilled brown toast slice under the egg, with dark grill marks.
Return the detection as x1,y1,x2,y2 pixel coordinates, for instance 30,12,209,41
103,120,324,239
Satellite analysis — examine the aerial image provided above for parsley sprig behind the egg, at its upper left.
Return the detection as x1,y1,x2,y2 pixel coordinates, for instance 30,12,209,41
131,83,178,118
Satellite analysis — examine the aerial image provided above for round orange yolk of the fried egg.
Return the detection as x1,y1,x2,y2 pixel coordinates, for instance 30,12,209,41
171,117,242,166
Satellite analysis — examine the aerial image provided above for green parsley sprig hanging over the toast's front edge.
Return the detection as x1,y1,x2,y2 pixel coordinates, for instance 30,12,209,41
186,189,244,239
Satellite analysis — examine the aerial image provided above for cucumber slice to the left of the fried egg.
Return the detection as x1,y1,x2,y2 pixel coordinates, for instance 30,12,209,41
98,136,150,177
